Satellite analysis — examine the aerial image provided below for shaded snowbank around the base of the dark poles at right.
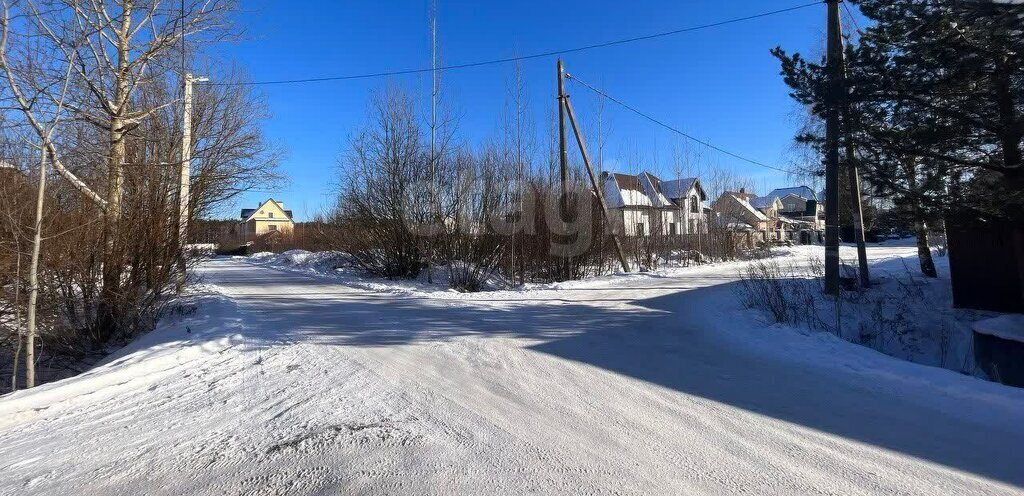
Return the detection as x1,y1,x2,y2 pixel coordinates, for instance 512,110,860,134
736,241,992,375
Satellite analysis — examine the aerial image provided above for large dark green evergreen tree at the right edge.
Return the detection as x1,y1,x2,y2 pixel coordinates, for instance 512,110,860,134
772,0,1024,275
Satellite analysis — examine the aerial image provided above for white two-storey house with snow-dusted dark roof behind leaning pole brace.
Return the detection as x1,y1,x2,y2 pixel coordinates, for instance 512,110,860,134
601,171,708,236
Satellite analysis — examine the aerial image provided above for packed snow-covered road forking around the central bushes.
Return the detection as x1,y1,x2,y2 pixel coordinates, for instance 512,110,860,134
0,250,1024,494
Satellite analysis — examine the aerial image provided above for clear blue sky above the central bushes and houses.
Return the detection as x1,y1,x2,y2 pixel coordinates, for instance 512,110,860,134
207,0,825,219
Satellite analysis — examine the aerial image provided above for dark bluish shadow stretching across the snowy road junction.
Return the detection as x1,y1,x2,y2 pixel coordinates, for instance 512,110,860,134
190,261,1024,485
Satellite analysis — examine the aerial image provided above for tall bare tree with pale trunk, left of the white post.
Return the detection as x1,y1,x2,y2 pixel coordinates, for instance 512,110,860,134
0,0,233,338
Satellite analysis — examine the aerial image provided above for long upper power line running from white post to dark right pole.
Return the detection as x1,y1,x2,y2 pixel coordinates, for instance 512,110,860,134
206,0,821,86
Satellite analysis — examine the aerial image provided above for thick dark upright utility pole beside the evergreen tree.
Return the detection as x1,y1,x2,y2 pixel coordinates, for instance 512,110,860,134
825,0,843,296
